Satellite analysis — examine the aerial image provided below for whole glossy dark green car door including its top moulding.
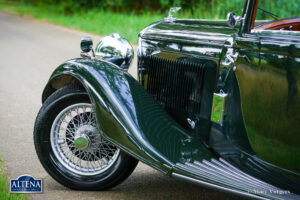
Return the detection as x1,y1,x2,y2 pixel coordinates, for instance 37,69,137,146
236,31,300,173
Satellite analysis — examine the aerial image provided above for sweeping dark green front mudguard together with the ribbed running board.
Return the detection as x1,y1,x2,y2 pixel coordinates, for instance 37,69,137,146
42,58,298,199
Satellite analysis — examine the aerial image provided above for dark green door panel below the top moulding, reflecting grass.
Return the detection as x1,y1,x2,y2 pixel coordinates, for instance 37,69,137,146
236,53,300,172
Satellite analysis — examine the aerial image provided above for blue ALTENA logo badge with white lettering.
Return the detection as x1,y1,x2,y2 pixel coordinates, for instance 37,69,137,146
10,174,42,193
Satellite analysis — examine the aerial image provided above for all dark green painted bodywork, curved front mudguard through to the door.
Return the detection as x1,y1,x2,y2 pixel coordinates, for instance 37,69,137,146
43,0,300,196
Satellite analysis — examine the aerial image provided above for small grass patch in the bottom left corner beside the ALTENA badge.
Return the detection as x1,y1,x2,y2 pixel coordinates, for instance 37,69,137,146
0,155,27,200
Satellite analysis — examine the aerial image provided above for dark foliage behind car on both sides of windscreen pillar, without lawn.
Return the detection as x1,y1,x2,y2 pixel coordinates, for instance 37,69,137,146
16,0,300,19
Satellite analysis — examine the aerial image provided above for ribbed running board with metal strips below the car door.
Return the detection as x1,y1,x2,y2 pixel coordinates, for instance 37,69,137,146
172,158,300,199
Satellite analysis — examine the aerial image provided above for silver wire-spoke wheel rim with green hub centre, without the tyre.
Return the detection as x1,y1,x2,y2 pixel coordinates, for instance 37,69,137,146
50,103,120,176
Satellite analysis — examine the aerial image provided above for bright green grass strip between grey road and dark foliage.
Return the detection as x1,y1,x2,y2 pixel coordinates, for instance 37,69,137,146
0,0,166,44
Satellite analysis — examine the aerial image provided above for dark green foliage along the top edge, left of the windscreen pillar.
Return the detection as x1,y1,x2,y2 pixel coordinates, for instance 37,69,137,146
21,0,243,16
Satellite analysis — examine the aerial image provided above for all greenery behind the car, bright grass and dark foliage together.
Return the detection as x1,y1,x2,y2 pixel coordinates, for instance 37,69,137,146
0,0,300,44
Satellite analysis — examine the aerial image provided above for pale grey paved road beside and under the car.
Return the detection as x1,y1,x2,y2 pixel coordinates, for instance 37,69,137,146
0,12,241,200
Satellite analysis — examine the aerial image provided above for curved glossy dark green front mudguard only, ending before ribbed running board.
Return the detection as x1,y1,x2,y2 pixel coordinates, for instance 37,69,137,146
43,58,213,174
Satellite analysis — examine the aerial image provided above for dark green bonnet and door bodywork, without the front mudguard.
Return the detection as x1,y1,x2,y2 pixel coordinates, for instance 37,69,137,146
138,1,300,176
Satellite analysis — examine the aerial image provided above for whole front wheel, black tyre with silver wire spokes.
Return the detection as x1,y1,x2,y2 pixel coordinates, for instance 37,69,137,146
34,85,138,190
